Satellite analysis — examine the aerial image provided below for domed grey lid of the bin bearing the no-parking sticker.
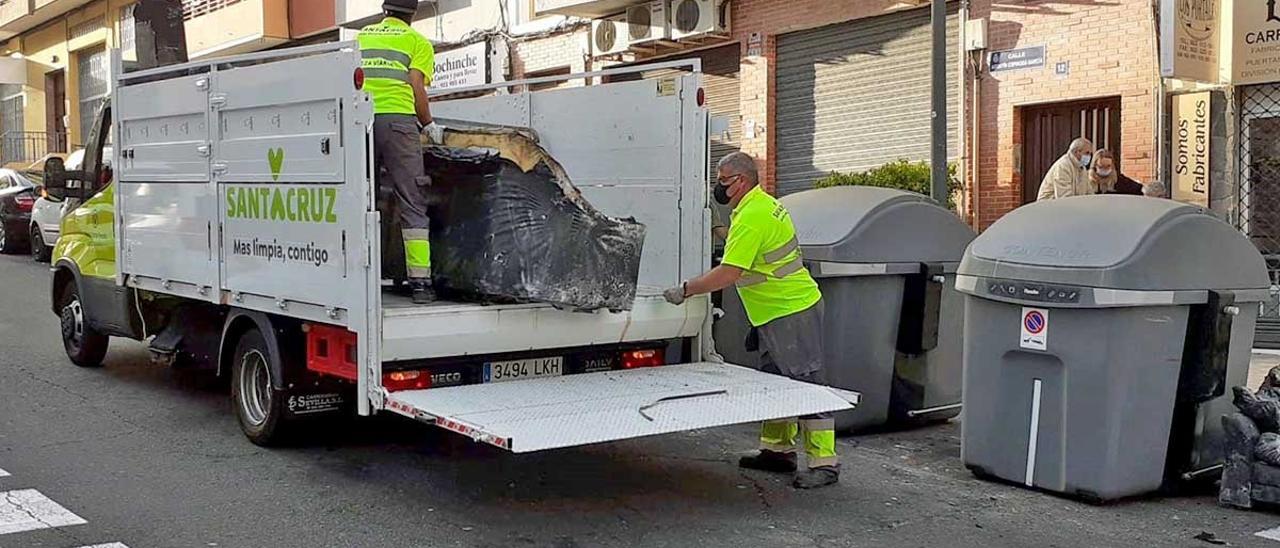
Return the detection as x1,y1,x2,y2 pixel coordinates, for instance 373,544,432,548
959,195,1271,291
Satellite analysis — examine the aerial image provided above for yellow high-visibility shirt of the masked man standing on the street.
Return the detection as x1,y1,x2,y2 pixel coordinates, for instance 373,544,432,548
721,187,822,326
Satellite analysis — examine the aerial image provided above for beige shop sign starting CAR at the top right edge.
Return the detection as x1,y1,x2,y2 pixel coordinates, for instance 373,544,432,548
1231,0,1280,86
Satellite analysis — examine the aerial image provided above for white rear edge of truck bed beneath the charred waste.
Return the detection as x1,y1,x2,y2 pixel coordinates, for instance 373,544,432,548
381,287,707,361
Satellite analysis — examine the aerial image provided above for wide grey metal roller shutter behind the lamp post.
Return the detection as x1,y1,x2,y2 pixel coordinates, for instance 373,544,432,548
774,3,961,195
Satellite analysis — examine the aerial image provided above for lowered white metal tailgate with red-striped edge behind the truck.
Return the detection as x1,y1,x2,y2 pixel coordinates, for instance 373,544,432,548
387,362,859,453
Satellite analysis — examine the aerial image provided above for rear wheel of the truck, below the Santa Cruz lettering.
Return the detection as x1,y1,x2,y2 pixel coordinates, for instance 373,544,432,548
232,329,288,447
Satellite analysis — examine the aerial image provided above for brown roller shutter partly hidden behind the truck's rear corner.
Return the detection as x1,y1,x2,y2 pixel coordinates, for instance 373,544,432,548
611,44,742,168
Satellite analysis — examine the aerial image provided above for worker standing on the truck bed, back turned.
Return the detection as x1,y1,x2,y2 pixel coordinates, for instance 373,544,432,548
356,0,444,303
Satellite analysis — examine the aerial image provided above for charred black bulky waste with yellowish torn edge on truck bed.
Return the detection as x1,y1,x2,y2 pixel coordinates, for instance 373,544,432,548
424,128,645,311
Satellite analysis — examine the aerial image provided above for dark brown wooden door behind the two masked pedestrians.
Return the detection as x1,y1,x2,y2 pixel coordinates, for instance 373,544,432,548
1021,97,1123,204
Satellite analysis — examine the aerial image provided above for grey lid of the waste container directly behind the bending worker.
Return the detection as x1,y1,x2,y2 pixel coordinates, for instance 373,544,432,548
781,187,974,264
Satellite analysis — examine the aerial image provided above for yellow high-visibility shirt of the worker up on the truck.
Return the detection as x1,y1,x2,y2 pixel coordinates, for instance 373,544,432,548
356,17,435,115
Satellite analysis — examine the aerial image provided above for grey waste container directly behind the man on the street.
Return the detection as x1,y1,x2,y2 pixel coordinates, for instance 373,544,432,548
716,187,974,430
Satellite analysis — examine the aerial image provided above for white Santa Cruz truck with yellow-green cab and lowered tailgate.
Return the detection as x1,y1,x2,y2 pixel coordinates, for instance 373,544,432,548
46,44,858,452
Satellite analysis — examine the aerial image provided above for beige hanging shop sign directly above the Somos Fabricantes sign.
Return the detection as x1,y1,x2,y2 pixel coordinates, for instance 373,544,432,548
1160,0,1218,83
